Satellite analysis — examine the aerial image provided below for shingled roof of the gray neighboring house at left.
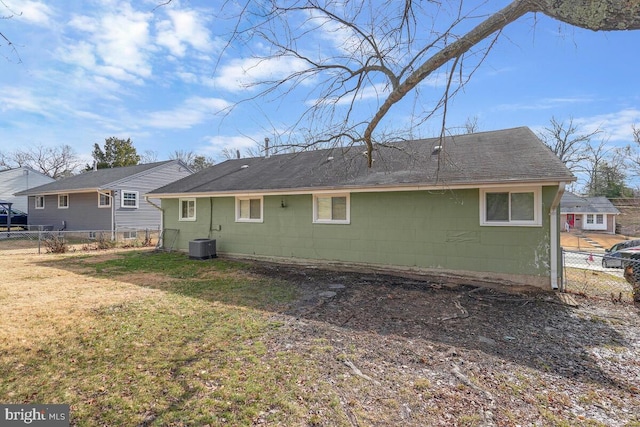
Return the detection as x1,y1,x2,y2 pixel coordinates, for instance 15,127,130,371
15,160,175,196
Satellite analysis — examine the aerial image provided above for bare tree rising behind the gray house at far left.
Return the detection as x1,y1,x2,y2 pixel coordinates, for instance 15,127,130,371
0,145,81,179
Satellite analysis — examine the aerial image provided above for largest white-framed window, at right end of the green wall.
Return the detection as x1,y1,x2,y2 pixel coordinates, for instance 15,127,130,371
480,187,542,226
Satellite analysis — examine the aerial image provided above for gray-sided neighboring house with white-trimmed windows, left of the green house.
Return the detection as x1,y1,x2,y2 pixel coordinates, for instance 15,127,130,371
17,160,193,237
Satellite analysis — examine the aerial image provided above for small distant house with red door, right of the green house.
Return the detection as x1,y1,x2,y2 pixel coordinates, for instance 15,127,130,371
560,192,620,234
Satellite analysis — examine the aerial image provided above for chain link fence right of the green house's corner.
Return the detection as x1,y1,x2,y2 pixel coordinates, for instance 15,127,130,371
562,250,640,302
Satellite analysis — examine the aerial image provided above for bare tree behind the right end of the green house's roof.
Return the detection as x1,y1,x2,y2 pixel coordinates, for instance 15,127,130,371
538,117,602,173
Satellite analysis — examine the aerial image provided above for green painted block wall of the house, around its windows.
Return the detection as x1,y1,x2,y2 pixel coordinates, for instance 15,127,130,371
162,187,557,278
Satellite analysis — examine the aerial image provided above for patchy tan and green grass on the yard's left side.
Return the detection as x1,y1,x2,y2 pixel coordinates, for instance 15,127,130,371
0,251,346,426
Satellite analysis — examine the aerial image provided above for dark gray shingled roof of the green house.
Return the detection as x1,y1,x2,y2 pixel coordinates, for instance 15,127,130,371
149,127,575,195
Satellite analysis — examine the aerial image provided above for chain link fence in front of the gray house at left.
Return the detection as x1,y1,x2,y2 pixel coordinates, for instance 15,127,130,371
0,228,160,254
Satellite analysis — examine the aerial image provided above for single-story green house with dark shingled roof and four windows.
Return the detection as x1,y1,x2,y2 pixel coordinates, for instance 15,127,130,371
148,127,575,289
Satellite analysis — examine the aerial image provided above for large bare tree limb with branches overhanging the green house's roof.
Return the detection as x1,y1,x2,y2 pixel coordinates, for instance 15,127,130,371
195,0,640,165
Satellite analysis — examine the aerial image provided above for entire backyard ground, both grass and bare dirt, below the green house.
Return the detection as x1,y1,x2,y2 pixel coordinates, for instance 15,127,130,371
0,249,640,427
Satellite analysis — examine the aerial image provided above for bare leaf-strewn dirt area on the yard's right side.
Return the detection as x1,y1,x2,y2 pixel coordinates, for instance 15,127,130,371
246,263,640,426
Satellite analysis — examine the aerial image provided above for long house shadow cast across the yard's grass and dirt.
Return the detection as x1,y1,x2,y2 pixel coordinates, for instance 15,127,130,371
38,252,630,396
